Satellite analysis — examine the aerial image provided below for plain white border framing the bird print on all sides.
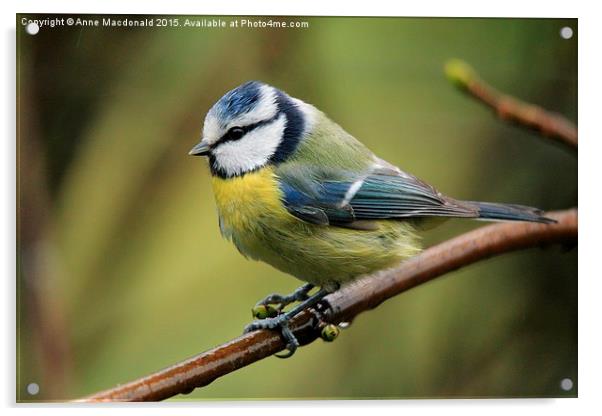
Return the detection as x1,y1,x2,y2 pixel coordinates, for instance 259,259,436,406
0,0,602,416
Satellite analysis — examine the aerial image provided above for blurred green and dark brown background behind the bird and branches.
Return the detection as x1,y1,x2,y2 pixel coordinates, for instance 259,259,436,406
17,15,577,401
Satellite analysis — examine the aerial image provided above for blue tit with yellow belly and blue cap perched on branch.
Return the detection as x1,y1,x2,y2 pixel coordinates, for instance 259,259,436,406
189,81,554,358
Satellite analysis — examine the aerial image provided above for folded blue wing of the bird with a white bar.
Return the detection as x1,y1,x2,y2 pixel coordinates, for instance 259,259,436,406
280,167,479,228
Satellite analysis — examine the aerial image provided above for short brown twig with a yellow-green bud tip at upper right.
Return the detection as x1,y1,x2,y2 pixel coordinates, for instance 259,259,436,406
445,59,577,149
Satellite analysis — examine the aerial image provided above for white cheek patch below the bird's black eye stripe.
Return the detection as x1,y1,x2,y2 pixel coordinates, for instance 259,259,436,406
212,114,286,176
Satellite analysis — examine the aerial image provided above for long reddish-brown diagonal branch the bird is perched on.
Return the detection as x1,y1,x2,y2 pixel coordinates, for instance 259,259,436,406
79,209,577,402
